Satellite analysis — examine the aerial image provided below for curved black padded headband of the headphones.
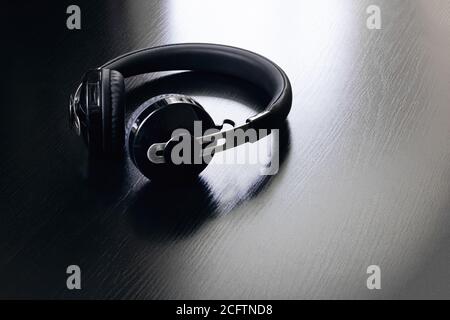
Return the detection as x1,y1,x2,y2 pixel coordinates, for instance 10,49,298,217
101,43,292,128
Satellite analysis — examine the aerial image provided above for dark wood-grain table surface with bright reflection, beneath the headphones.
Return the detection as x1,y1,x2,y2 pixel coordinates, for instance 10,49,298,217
0,0,450,299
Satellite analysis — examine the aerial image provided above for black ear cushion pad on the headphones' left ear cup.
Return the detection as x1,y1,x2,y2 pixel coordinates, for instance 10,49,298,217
104,70,125,155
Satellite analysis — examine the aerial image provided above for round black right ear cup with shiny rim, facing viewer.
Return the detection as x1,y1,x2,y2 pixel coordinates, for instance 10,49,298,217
128,94,215,183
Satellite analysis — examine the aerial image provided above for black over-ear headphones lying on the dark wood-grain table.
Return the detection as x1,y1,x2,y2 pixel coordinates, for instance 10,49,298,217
69,43,292,179
